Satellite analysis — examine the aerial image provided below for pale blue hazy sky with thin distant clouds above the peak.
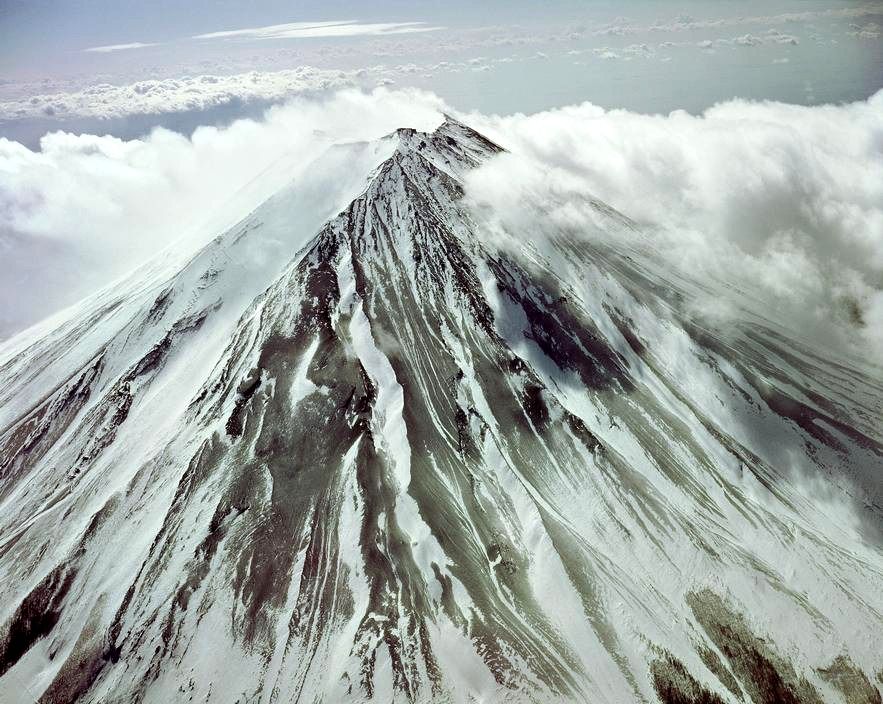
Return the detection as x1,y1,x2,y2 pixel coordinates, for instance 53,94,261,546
0,0,883,147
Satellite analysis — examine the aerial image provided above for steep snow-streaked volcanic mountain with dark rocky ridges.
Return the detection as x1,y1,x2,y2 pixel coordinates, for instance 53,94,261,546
0,118,883,704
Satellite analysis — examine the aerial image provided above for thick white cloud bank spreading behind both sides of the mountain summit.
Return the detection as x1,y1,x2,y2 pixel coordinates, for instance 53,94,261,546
0,89,883,360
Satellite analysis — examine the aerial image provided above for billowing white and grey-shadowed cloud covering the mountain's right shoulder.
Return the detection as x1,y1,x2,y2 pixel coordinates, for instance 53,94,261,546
469,91,883,354
